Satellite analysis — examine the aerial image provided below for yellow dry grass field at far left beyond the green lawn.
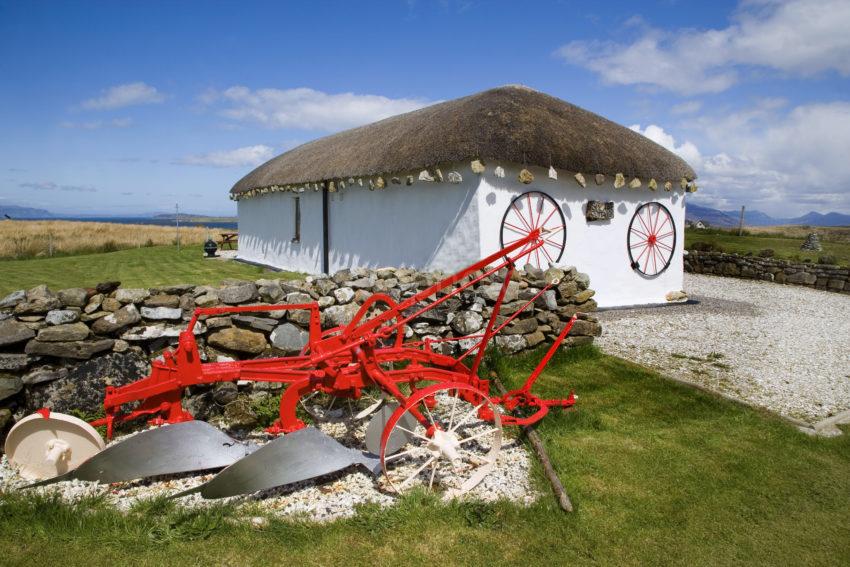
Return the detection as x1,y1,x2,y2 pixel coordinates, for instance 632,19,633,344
0,220,218,258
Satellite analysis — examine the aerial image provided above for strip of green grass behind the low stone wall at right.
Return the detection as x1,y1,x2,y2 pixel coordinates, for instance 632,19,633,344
685,228,850,266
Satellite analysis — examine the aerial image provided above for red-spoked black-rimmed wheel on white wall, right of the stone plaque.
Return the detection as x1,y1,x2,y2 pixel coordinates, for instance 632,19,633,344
627,203,676,276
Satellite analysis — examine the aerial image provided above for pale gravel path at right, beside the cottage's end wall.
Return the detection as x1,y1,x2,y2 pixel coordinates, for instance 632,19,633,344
597,274,850,423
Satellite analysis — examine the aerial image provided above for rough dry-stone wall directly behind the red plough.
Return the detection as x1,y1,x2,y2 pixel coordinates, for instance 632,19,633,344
0,266,601,438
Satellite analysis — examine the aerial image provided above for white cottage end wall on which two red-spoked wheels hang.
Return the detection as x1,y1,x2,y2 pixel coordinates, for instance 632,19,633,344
478,166,685,307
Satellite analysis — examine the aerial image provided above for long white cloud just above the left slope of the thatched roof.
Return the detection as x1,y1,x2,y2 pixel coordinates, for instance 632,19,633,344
204,86,431,131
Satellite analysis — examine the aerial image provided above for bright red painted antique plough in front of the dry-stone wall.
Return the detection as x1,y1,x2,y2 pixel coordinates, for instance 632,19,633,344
10,229,576,497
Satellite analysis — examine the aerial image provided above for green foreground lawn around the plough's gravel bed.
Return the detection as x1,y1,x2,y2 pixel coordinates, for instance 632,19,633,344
0,348,850,566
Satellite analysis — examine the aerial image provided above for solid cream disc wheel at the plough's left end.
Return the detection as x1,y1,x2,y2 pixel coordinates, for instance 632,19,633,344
5,411,105,480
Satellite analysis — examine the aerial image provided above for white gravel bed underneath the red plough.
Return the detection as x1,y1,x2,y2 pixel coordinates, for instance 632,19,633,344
0,398,539,522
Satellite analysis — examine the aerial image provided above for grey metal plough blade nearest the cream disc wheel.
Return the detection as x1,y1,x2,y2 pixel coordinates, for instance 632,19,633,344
26,421,258,488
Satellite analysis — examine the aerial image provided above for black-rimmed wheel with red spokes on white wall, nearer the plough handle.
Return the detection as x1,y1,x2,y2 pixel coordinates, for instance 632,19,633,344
499,191,567,269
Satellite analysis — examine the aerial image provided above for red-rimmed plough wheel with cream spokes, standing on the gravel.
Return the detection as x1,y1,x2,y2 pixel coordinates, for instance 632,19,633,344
380,382,502,498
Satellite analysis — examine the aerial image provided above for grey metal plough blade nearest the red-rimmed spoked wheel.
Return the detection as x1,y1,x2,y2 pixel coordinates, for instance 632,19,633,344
174,427,381,498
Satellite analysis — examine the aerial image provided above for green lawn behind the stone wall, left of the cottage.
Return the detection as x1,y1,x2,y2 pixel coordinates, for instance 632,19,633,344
0,246,298,296
